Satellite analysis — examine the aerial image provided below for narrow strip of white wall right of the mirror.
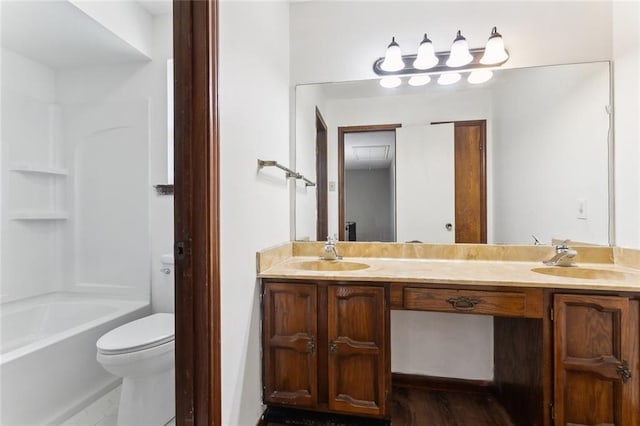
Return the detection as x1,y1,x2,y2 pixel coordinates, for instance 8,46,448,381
613,1,640,248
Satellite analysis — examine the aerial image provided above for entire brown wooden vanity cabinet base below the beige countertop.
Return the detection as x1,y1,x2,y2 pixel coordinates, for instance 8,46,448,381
262,272,640,426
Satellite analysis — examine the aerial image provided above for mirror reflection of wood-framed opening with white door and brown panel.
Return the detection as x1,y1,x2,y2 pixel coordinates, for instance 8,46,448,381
338,120,487,243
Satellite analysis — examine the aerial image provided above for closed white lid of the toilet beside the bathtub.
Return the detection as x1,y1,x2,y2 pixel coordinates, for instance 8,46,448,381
96,313,175,354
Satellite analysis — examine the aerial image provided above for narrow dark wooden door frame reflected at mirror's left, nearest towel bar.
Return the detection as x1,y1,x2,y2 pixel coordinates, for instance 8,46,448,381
316,107,329,241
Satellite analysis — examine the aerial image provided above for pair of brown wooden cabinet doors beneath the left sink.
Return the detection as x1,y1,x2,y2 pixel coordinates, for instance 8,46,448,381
262,280,391,417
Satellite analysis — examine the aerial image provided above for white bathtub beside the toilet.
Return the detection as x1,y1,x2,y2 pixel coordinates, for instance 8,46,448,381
0,293,150,426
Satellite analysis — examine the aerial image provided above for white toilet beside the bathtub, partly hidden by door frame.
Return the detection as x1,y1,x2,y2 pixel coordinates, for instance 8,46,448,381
96,255,175,426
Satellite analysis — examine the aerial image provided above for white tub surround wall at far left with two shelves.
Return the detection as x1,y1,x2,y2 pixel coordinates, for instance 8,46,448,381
0,48,60,302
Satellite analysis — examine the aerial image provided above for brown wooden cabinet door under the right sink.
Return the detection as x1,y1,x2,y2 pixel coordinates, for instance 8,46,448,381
554,294,640,426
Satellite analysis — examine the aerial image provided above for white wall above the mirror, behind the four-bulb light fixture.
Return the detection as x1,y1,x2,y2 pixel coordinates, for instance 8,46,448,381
291,1,612,84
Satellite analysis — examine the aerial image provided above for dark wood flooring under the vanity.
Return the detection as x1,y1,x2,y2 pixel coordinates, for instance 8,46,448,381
258,386,514,426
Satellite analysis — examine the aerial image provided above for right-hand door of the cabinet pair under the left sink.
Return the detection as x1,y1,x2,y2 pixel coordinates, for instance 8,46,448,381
327,285,391,416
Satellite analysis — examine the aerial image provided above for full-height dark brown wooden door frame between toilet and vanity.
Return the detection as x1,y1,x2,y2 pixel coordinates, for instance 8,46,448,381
173,0,221,426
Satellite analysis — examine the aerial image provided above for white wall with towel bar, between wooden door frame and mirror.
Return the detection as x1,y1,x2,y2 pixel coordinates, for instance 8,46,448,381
219,2,290,426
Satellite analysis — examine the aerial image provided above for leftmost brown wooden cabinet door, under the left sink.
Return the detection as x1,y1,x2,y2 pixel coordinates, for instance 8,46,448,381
262,283,318,407
